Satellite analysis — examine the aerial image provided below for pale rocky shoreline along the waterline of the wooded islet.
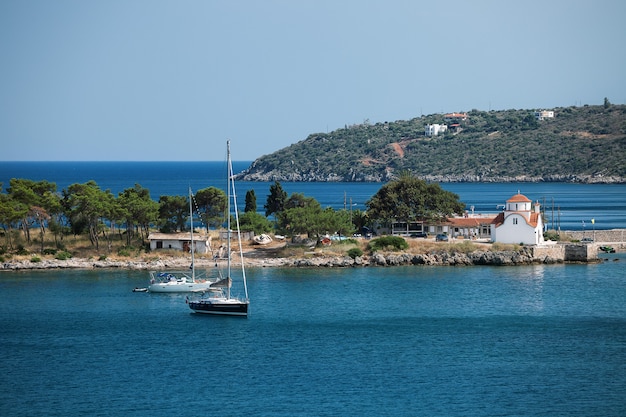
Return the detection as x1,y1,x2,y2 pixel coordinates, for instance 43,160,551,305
0,248,604,271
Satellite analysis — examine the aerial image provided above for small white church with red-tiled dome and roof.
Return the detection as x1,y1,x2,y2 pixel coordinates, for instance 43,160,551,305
491,191,543,245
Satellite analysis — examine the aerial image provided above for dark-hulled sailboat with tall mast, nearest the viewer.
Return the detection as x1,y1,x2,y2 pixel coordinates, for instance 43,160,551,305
186,141,250,317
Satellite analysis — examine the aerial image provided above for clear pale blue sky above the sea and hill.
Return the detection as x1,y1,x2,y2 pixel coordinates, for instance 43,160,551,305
0,0,626,161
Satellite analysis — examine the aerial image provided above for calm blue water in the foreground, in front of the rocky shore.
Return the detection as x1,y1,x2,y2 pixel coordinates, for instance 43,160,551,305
0,254,626,417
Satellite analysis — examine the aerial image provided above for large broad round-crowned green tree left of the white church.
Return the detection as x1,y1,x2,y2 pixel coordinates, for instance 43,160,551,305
365,173,465,224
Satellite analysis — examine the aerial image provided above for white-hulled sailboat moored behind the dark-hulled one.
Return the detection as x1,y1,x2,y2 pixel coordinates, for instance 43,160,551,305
148,187,216,293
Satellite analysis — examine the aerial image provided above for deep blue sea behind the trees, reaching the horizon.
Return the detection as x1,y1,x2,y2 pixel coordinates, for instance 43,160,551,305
0,161,626,230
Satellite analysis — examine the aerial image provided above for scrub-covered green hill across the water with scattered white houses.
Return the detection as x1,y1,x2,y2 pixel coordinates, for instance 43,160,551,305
238,100,626,183
